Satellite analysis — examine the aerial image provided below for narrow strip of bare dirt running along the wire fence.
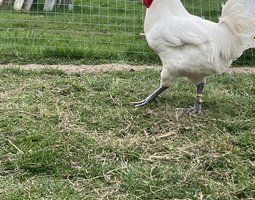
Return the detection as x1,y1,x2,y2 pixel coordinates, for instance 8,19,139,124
0,64,255,73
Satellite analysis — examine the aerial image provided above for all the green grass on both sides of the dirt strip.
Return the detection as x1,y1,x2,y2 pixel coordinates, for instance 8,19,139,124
0,0,255,200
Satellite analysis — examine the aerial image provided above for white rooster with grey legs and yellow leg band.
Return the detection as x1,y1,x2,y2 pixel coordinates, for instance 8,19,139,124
131,0,255,113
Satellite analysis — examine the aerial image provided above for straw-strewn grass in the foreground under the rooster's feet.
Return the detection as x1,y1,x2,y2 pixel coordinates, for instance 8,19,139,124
0,68,255,200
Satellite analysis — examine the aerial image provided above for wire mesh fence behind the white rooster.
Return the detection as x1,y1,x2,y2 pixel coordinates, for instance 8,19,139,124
0,0,255,65
